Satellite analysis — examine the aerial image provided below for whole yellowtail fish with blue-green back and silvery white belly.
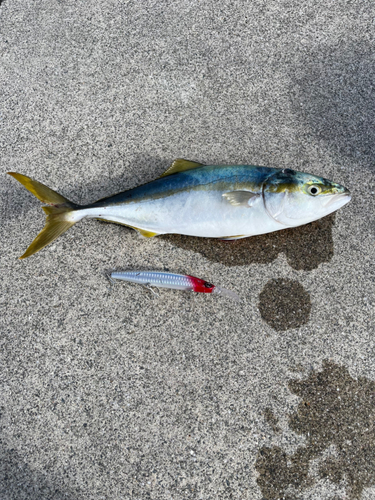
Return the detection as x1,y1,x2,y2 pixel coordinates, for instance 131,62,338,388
9,159,351,259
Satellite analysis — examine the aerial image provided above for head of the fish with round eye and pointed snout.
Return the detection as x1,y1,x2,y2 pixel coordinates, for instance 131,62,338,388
263,169,351,227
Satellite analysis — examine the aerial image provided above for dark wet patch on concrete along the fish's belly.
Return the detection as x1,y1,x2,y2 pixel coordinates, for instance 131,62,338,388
164,214,335,271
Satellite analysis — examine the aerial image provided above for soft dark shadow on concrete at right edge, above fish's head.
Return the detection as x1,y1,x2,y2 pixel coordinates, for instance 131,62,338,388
289,42,375,171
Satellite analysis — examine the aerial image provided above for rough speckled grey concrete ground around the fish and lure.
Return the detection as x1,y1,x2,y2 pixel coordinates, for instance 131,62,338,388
0,0,375,500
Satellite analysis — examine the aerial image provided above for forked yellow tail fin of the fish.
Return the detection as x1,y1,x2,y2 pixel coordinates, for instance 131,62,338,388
8,172,84,259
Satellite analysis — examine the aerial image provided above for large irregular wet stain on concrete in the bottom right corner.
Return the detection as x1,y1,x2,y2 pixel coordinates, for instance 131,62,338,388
255,361,375,500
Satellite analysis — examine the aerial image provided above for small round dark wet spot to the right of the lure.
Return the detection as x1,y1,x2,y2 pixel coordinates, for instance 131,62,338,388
258,278,311,332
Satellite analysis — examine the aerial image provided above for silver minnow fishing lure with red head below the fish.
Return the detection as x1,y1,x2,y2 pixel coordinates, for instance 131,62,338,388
110,271,239,300
